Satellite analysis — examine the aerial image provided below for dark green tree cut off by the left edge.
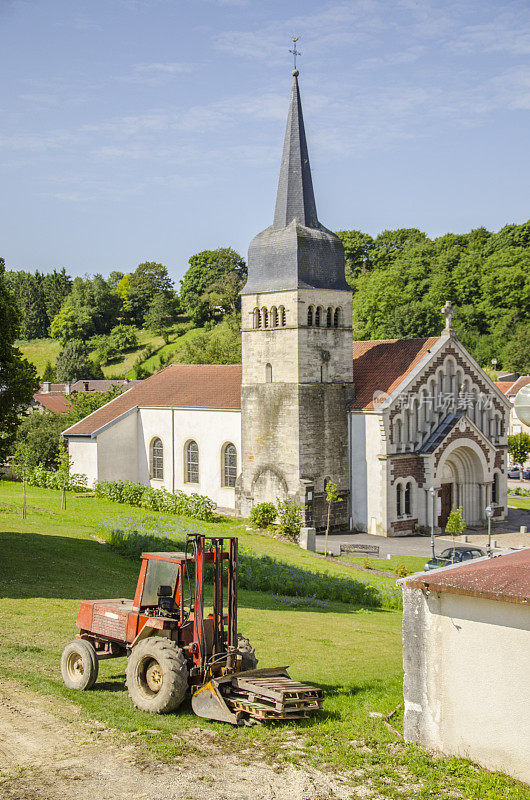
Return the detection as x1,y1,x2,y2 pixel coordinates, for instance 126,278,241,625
0,259,39,460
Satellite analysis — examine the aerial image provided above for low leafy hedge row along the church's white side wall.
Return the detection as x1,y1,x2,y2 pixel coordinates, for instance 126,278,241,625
94,481,217,522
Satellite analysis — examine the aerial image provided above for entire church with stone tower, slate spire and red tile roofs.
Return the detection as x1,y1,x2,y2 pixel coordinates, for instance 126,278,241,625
63,70,510,536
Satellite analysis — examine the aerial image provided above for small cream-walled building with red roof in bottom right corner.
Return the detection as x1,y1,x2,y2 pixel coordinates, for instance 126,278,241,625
400,549,530,783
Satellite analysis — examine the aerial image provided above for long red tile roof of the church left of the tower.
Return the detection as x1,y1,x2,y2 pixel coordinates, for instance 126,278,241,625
63,364,241,436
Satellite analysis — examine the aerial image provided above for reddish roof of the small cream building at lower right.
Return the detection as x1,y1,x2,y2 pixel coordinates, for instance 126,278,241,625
402,547,530,604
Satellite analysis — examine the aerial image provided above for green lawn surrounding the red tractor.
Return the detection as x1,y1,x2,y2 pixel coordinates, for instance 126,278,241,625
0,481,530,800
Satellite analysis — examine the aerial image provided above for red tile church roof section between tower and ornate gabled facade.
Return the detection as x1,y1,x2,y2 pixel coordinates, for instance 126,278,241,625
351,336,439,408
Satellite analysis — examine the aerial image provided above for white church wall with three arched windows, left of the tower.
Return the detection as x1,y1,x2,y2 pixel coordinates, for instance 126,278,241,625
138,408,241,508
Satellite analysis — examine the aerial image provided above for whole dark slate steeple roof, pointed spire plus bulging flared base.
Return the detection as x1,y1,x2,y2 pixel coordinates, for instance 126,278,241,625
241,69,351,294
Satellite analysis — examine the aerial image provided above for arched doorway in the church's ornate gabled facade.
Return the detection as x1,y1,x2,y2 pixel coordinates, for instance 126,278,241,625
438,445,486,527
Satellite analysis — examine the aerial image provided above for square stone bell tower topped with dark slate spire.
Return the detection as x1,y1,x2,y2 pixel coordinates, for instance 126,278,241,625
236,70,353,528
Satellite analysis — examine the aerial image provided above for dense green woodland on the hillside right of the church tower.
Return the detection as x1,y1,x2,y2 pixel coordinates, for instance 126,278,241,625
338,222,530,372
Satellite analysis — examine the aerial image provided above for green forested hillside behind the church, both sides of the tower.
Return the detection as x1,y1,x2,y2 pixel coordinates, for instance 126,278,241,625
6,222,530,380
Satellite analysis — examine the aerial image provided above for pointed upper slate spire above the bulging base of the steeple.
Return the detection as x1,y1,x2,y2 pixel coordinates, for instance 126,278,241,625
273,69,318,229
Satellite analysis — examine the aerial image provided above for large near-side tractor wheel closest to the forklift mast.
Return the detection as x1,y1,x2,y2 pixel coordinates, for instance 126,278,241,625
126,636,188,714
